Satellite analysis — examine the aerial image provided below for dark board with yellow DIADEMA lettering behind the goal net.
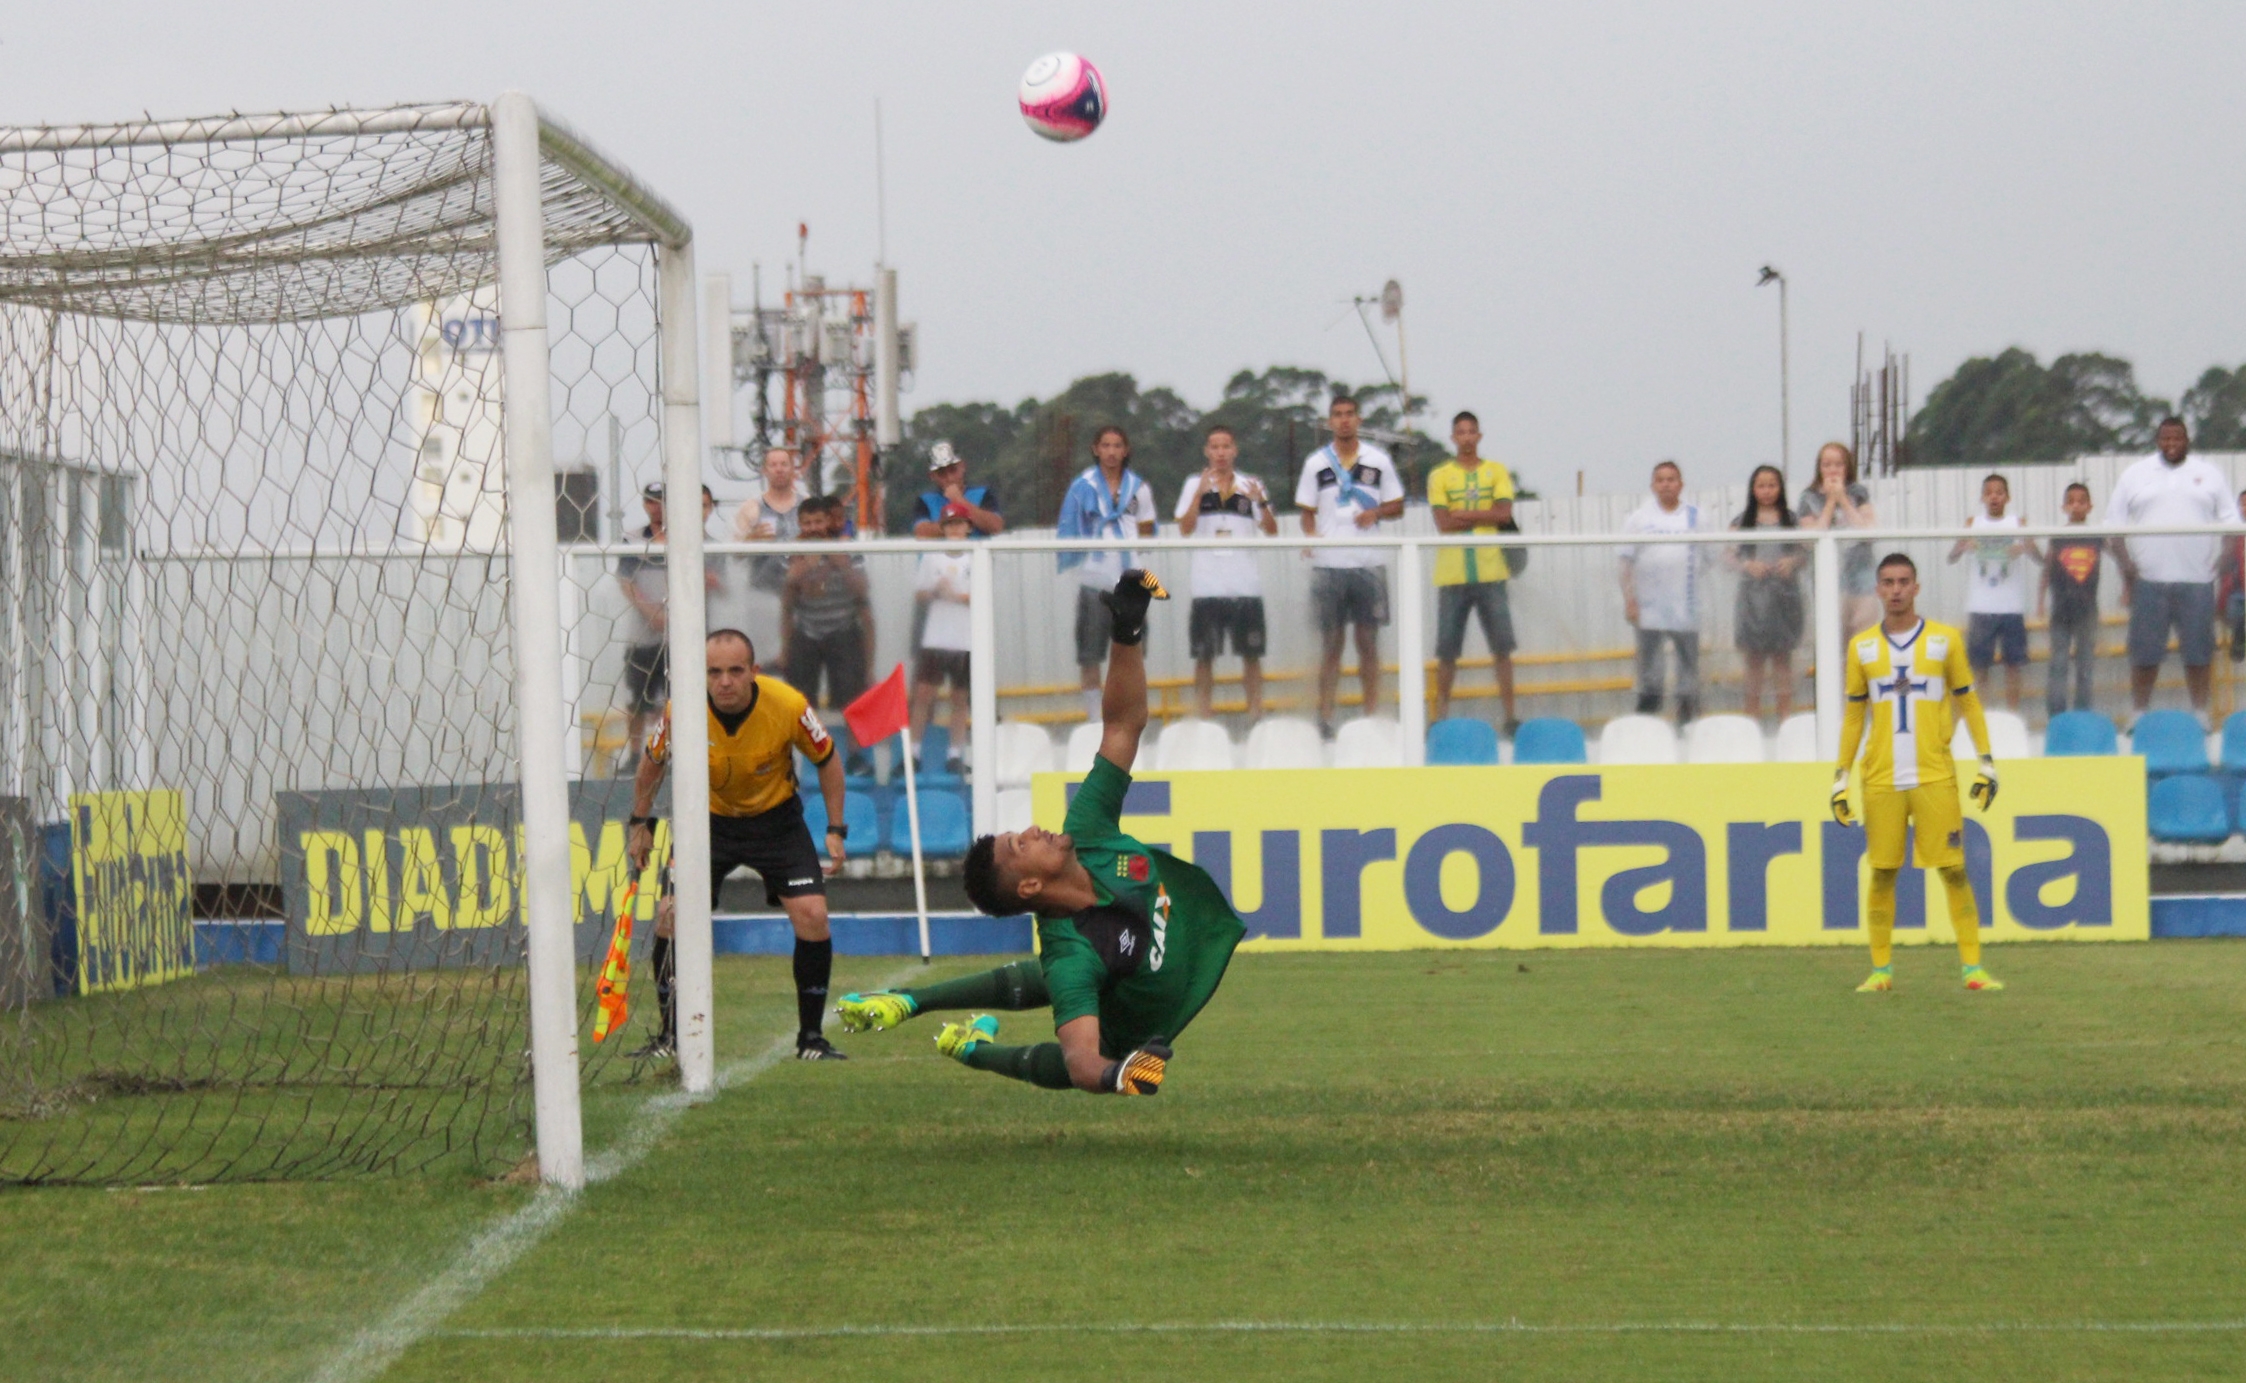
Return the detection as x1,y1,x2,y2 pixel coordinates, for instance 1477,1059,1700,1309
279,781,669,974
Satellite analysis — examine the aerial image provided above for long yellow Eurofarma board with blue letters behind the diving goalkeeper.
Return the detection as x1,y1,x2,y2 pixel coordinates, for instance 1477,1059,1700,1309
1035,759,2152,950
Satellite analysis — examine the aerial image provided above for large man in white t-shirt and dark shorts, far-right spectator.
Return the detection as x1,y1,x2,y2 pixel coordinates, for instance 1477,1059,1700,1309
2105,418,2239,718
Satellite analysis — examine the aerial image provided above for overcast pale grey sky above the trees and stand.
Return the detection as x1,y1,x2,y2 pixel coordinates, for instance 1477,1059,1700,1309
0,0,2246,487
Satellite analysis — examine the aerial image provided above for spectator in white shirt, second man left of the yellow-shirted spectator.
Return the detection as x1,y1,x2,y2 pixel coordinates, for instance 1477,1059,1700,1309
1177,422,1278,725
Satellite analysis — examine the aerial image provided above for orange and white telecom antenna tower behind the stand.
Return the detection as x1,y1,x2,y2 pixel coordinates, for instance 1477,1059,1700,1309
703,225,914,534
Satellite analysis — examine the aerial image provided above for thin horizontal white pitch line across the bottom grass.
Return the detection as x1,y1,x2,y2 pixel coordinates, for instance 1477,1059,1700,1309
436,1320,2246,1343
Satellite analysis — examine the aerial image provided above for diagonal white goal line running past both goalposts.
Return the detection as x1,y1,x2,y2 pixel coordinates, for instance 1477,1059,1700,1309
312,961,921,1383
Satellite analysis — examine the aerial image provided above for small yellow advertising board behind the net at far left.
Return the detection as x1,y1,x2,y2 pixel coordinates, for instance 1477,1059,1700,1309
70,790,195,995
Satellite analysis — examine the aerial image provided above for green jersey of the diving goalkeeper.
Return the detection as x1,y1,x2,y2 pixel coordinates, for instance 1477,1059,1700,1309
1038,757,1247,1057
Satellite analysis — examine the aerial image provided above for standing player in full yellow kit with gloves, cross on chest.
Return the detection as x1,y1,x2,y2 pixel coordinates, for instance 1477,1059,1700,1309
1833,552,2003,995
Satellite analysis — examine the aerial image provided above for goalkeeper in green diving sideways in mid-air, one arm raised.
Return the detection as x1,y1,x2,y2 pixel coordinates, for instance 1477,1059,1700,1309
836,570,1247,1096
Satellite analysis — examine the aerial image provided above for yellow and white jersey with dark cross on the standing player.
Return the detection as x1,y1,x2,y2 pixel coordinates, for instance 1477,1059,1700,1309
1839,620,1988,793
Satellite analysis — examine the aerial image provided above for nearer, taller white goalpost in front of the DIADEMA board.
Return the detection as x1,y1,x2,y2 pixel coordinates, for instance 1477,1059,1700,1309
492,92,583,1190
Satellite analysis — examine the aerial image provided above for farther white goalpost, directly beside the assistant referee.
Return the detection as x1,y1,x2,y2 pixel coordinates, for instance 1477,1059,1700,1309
656,240,716,1096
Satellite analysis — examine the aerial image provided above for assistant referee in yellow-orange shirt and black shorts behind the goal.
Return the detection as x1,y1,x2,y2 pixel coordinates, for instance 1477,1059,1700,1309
631,629,849,1062
